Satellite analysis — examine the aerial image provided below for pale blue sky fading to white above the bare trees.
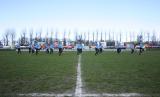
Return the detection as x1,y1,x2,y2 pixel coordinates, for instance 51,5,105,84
0,0,160,40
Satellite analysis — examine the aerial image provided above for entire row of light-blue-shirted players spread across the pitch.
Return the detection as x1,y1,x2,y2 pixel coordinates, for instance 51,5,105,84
17,42,144,56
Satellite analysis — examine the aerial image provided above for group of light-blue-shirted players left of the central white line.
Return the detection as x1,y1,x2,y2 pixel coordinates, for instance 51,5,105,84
16,43,63,56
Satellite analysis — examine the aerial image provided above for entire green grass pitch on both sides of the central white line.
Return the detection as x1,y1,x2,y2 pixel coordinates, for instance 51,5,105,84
0,51,160,97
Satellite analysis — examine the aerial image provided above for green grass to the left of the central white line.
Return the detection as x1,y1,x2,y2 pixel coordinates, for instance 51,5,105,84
0,51,77,95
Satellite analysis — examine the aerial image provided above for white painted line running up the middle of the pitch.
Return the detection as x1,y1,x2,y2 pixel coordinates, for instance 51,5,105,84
75,55,82,97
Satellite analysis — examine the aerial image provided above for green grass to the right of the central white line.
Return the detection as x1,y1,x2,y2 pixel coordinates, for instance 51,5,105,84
82,51,160,95
